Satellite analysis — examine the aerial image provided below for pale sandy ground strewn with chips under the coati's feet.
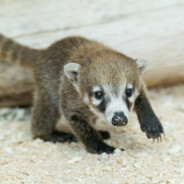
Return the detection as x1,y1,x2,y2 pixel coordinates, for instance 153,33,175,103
0,85,184,184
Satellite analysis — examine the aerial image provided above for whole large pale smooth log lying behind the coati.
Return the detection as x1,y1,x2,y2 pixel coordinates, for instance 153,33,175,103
0,0,184,107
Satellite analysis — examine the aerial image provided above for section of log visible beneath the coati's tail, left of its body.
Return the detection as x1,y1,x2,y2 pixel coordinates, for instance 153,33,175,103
0,61,34,107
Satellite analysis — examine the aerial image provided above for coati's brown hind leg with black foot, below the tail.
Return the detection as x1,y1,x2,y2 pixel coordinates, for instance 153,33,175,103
31,89,76,142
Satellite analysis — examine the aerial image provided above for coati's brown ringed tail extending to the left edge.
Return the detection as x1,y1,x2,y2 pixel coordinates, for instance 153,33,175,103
0,34,40,68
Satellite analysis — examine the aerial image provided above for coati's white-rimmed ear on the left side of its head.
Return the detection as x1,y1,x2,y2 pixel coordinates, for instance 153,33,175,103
64,63,80,87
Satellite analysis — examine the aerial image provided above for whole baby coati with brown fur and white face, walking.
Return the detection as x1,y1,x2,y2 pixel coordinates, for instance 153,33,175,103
0,35,164,154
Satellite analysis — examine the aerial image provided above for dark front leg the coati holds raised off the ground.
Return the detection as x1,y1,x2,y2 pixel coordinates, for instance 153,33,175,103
135,89,164,140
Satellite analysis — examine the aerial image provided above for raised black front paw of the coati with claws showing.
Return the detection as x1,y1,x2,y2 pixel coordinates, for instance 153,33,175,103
141,118,164,141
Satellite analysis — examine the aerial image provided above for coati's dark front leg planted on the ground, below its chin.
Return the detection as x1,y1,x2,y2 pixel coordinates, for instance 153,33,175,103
67,116,115,154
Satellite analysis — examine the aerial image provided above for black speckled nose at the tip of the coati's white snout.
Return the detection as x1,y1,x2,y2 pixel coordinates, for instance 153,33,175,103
112,112,128,126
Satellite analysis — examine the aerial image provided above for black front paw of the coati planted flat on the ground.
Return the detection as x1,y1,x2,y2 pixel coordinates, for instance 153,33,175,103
86,140,116,154
